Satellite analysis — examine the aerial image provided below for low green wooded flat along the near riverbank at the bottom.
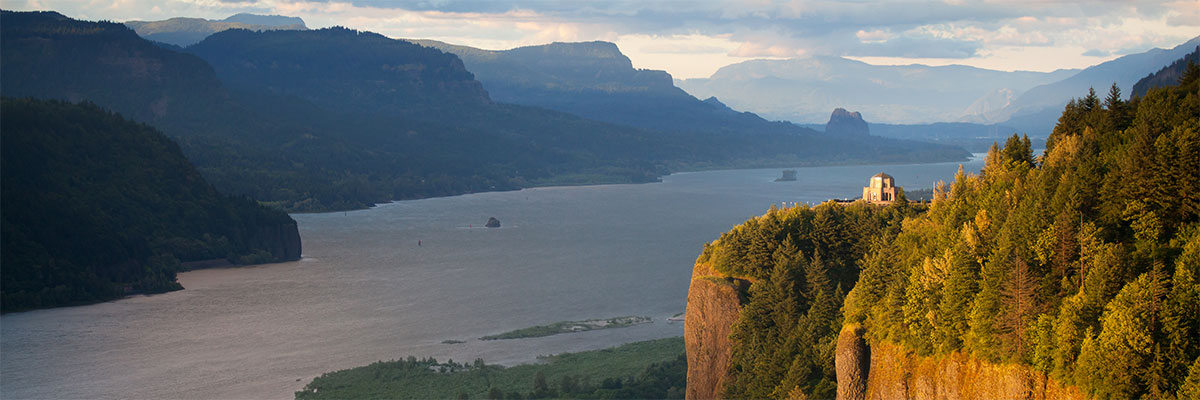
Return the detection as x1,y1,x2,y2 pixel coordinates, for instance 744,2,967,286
296,338,686,399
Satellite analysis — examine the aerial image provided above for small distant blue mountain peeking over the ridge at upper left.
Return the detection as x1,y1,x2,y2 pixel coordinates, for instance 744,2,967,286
125,13,308,47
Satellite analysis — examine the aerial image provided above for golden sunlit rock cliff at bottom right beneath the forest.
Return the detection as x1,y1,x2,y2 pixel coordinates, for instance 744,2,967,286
836,327,1087,400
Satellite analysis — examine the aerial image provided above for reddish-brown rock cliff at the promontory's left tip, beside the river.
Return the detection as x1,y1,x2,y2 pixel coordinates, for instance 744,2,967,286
683,257,746,400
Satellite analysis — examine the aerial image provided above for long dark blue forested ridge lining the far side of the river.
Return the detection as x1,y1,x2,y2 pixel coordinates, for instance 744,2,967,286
0,11,966,211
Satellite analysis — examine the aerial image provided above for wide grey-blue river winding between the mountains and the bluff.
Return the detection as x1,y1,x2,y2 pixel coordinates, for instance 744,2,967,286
0,155,983,399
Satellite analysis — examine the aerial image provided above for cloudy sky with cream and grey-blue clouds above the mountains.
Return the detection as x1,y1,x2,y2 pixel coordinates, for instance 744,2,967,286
7,0,1200,78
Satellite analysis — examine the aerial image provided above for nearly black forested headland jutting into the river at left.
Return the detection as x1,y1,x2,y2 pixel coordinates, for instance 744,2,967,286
0,97,300,311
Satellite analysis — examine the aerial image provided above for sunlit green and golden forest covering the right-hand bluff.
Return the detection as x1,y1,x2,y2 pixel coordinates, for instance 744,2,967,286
704,65,1200,399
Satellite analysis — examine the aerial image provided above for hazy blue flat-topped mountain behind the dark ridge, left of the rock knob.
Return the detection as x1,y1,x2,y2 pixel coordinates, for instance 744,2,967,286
412,40,812,135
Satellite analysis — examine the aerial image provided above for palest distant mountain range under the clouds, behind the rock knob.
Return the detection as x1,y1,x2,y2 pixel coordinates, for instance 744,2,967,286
677,56,1078,124
